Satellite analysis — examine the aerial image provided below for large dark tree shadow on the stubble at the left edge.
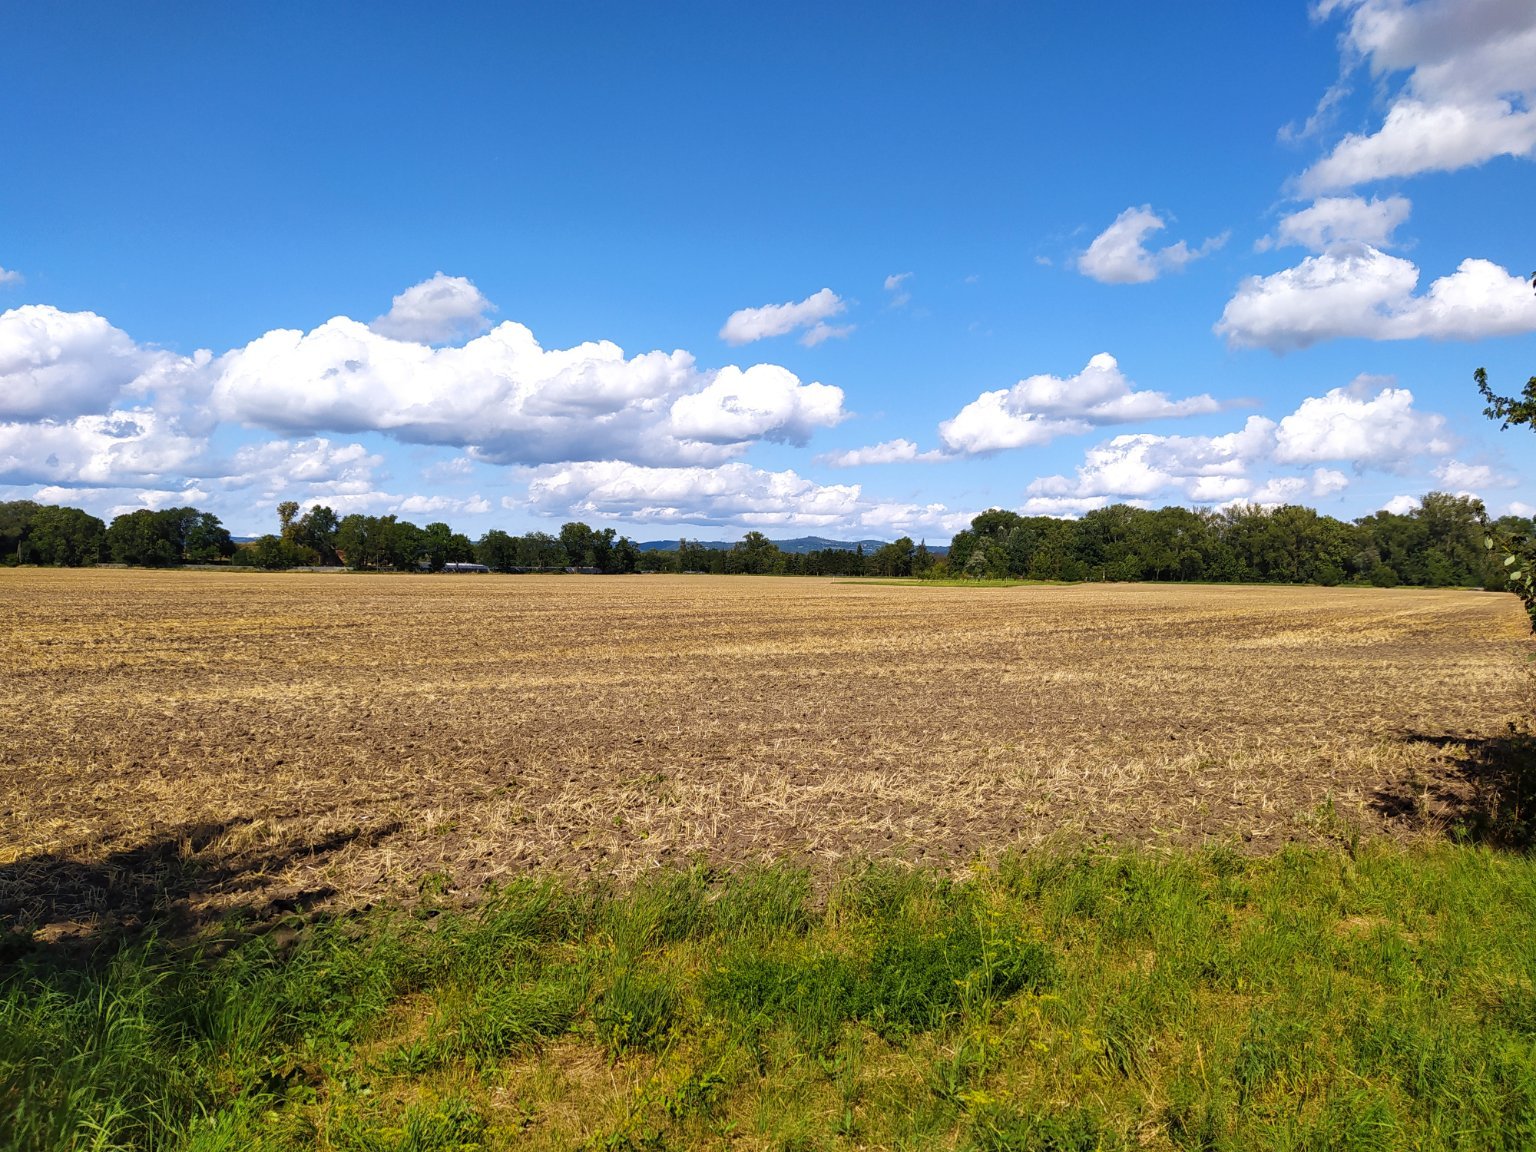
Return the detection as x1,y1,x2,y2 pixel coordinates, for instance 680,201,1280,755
0,819,398,966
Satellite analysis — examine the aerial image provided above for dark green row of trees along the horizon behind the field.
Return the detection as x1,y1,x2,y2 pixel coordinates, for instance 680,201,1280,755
0,492,1536,588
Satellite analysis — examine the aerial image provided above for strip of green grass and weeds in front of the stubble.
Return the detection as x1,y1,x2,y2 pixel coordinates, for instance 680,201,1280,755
9,843,1536,1152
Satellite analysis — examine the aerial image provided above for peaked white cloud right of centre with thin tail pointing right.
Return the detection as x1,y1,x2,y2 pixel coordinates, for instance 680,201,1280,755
938,352,1221,455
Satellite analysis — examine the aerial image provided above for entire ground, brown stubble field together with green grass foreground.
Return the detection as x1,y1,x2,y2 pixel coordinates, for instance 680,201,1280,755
0,570,1536,1152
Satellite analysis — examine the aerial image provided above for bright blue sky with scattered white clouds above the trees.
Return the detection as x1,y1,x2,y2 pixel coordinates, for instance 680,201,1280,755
0,0,1536,541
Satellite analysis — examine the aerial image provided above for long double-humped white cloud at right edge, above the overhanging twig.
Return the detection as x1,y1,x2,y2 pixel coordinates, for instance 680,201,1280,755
1215,246,1536,352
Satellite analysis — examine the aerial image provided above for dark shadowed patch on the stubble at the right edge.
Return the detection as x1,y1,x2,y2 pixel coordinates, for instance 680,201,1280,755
1373,727,1536,851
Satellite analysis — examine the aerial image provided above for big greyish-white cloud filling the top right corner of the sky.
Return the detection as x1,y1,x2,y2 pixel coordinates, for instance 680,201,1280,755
1298,0,1536,195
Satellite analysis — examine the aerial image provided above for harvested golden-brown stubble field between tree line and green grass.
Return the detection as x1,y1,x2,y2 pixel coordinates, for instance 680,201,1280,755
0,570,1531,935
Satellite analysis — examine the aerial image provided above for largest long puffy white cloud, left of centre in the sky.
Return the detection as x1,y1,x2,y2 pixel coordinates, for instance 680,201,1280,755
212,316,846,464
